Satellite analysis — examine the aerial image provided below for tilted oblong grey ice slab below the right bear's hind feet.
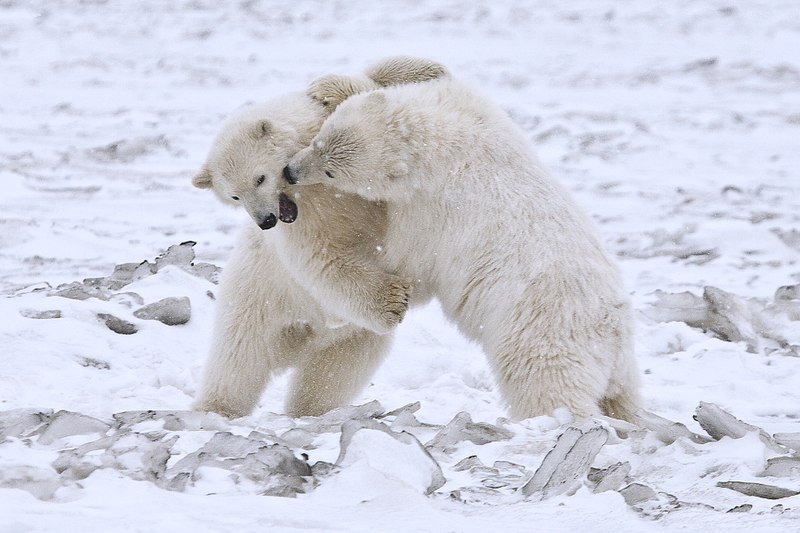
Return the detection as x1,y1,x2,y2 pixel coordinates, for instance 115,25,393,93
522,426,608,499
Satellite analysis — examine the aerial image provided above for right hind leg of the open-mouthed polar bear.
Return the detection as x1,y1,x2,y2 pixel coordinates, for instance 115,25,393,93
286,327,393,416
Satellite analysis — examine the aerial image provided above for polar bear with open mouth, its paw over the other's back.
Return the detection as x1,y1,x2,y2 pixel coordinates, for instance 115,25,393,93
192,57,447,417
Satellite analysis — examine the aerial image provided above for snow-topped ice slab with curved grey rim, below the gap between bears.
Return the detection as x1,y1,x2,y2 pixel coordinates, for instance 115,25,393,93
336,419,446,494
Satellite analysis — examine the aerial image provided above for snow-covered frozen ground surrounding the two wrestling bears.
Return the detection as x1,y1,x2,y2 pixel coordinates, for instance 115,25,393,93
0,0,800,533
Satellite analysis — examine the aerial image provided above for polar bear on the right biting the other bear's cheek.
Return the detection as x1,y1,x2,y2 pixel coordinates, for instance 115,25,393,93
284,78,639,421
